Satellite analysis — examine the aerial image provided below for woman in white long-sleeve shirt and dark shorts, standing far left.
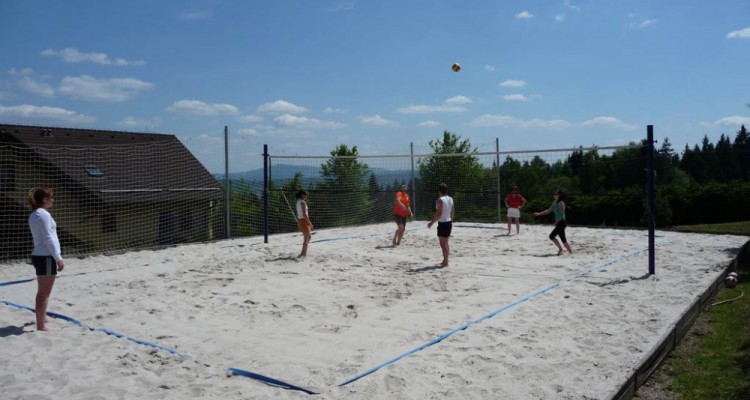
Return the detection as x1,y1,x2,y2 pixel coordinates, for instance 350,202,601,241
28,188,65,331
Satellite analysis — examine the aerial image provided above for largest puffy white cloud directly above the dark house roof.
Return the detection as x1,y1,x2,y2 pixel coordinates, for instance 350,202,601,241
58,75,154,103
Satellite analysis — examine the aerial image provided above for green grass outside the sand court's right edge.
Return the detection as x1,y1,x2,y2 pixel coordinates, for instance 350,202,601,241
639,222,750,400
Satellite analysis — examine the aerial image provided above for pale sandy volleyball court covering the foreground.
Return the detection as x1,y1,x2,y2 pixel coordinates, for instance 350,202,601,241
0,221,746,400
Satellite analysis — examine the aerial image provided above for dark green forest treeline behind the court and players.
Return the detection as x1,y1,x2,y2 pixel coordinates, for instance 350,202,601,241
219,125,750,235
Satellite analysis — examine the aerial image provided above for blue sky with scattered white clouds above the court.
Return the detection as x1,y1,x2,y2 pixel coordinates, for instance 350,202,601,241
0,0,750,172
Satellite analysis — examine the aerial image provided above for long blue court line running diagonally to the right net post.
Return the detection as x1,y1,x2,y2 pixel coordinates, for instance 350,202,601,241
336,244,648,387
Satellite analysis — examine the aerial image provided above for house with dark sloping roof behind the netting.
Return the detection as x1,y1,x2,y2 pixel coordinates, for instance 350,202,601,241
0,124,223,259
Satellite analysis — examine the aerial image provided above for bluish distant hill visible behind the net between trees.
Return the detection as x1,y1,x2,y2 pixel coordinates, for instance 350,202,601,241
214,164,419,187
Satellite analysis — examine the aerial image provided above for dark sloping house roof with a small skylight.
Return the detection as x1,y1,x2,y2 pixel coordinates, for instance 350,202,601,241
0,124,222,203
